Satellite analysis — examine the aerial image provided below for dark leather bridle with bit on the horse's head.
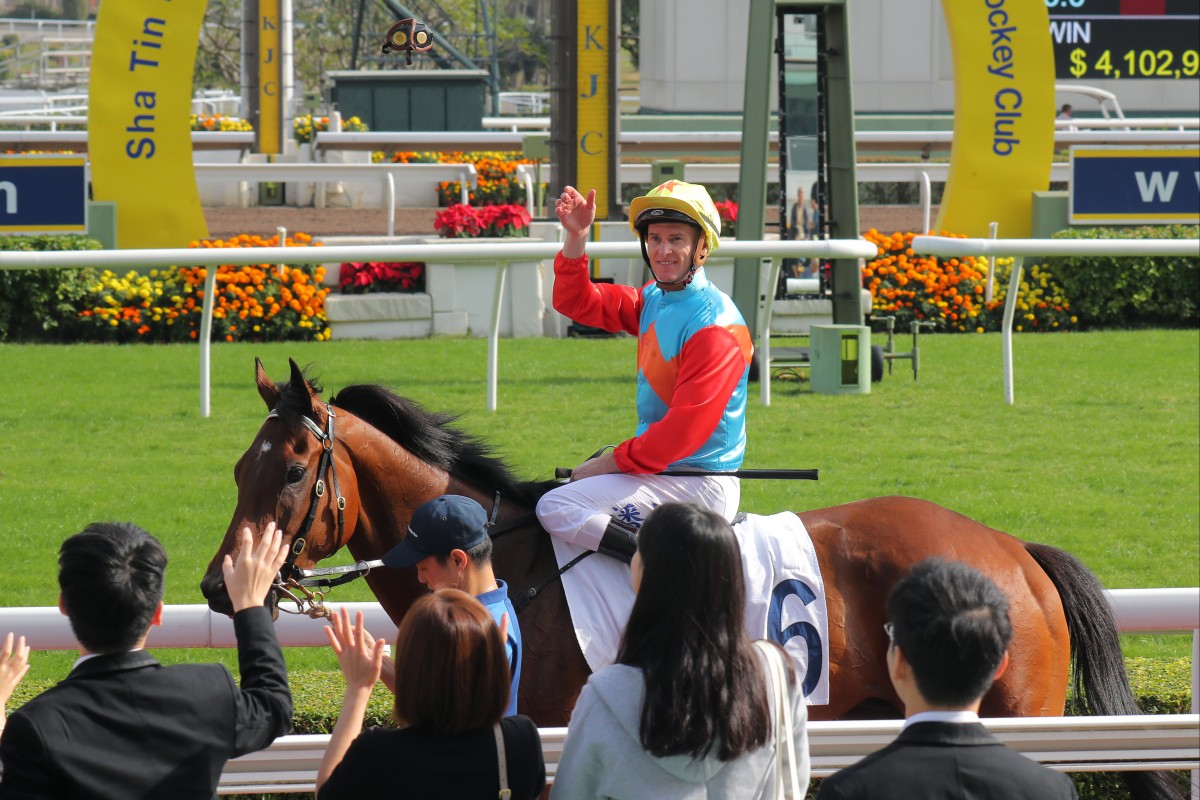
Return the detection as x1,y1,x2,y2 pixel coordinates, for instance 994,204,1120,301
266,403,383,619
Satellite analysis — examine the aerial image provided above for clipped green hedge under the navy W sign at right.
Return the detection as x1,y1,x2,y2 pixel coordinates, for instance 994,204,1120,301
1045,225,1200,327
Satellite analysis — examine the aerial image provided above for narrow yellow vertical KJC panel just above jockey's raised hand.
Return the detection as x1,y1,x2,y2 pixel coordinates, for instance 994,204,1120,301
575,0,619,219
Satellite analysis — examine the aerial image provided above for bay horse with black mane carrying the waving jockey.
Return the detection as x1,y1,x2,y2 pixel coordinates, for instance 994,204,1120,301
200,359,1176,800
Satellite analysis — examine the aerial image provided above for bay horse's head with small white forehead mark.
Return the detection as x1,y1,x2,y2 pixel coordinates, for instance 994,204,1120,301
200,359,359,614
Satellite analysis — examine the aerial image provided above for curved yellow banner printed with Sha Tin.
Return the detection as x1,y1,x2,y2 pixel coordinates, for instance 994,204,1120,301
88,0,208,248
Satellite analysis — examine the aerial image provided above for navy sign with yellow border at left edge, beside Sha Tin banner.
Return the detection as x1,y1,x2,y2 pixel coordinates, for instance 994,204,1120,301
0,155,88,234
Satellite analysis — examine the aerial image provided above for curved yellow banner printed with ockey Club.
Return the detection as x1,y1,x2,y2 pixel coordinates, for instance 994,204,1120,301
936,0,1055,239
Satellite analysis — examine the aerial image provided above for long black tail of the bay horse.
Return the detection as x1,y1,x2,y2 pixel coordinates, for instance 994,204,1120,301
1025,542,1183,800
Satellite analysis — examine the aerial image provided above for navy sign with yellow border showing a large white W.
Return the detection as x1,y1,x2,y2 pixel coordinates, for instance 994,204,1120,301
1069,145,1200,225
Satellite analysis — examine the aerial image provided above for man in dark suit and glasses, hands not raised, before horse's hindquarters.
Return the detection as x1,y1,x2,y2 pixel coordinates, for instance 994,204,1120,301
817,559,1076,800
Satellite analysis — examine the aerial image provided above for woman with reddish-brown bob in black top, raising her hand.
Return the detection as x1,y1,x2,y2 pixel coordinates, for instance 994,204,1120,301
317,589,546,800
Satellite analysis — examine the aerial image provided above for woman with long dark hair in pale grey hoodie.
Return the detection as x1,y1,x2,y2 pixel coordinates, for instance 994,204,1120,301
552,503,809,800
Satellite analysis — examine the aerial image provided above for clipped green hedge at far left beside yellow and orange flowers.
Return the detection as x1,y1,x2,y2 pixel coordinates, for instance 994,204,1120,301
0,235,103,342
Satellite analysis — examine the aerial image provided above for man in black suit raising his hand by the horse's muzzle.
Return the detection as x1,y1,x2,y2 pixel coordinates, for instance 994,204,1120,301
0,523,292,800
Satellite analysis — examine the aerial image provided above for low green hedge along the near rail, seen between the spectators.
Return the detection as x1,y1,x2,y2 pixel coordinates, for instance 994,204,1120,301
8,658,1192,800
